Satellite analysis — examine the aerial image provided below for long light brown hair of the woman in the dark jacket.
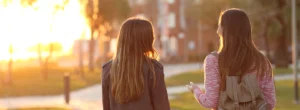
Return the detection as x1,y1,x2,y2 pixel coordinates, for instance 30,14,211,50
110,18,157,104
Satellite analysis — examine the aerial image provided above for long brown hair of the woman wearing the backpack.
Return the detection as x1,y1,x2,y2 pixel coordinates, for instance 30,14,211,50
218,9,272,90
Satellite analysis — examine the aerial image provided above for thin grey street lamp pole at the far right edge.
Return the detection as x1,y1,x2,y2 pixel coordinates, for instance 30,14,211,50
291,0,299,104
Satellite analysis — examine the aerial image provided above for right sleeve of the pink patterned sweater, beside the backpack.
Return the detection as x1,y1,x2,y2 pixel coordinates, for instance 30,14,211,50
260,68,276,110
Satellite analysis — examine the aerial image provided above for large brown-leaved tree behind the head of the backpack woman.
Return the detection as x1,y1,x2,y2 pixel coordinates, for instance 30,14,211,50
187,0,290,67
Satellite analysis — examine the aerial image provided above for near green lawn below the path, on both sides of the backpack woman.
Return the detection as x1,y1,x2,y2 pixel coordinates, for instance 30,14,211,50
170,80,300,110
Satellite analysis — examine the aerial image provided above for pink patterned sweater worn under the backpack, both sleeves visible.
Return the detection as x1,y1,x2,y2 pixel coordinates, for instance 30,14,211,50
193,54,276,109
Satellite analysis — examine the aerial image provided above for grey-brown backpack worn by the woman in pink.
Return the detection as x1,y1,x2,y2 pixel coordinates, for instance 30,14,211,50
212,52,268,110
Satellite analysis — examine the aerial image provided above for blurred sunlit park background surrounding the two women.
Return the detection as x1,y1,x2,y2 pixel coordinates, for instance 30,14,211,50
0,0,300,110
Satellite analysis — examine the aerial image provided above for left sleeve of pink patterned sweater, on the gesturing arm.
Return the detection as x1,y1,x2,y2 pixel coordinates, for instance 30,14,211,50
193,55,221,108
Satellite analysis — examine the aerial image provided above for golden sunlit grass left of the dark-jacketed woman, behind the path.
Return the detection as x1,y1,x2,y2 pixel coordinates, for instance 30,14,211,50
0,67,101,98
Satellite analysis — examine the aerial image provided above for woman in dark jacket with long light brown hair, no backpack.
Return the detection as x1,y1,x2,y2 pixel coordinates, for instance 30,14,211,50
102,18,170,110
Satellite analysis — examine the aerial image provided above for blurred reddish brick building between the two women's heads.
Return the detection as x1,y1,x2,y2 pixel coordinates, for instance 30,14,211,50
100,0,218,62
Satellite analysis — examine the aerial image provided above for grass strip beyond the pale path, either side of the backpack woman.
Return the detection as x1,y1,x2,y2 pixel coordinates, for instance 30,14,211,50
166,68,292,86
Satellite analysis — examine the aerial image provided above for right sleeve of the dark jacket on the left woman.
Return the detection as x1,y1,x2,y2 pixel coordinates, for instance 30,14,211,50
151,68,170,110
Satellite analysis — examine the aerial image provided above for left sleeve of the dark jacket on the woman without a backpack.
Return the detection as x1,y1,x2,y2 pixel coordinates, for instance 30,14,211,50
101,68,110,110
